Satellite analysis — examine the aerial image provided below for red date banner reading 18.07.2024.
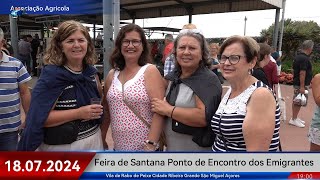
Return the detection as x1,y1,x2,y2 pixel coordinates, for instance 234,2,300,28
0,152,95,179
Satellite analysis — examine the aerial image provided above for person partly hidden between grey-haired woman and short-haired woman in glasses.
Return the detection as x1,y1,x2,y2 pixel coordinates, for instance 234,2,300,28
209,43,224,84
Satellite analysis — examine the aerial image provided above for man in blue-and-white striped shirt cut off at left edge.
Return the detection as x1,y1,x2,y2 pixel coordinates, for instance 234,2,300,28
0,28,31,151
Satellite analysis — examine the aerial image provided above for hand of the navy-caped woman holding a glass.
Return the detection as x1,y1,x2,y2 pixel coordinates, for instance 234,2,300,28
79,104,103,121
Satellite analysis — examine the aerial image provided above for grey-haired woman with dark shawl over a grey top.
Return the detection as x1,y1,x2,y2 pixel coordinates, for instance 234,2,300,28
152,29,222,151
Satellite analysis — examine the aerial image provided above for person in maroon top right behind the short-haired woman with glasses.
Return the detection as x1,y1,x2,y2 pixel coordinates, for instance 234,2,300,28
259,43,279,90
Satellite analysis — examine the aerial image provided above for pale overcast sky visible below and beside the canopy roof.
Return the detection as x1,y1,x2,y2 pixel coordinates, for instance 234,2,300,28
124,0,320,38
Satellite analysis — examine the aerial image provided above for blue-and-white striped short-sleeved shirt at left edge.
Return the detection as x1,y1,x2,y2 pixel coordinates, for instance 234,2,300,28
0,53,31,133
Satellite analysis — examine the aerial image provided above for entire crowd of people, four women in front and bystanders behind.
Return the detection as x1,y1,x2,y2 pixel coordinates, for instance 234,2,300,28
0,20,320,152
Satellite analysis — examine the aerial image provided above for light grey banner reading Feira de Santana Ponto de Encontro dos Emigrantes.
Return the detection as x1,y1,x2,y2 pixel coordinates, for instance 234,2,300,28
85,153,320,172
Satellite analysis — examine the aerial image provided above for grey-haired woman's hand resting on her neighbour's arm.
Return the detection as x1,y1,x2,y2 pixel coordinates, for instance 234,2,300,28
151,98,173,117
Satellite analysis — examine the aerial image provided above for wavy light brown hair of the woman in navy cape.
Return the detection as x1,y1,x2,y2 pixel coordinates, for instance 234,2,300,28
44,20,98,66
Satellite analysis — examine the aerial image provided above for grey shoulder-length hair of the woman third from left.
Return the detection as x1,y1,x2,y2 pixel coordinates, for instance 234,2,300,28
172,29,212,72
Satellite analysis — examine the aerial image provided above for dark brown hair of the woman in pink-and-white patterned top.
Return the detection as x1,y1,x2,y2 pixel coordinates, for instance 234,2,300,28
110,24,151,71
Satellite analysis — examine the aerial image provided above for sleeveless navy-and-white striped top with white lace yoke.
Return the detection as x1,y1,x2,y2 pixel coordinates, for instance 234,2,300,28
211,81,280,151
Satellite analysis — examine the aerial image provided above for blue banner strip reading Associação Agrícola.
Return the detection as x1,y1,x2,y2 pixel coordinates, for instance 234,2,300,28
0,0,102,15
